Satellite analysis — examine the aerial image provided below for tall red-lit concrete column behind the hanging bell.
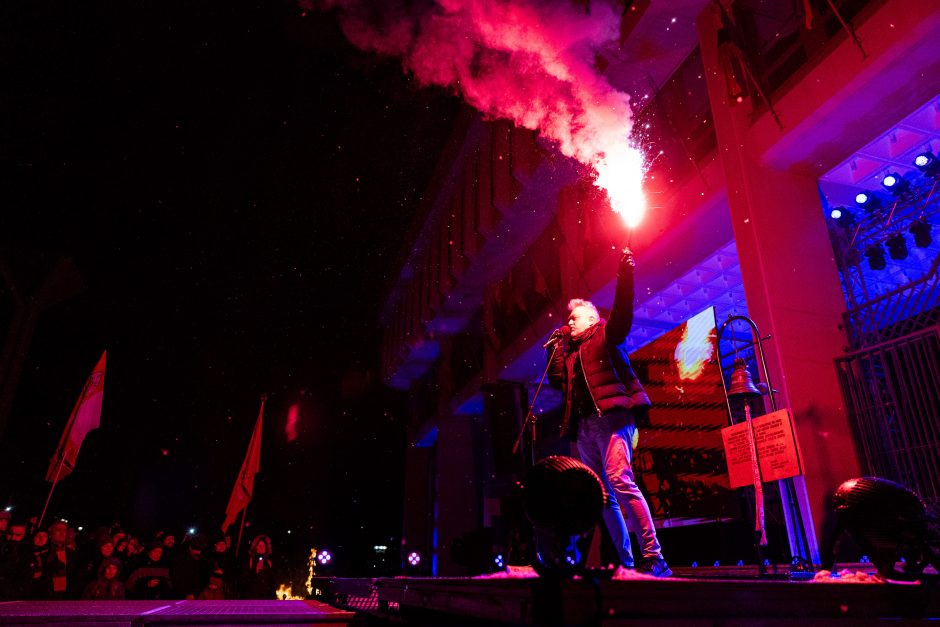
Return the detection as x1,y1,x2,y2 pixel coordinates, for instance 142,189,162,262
699,7,860,558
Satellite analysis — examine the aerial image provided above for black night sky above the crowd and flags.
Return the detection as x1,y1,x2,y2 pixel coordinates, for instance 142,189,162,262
0,0,461,576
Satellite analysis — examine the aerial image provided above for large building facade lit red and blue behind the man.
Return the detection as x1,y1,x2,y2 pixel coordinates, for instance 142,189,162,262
383,0,940,575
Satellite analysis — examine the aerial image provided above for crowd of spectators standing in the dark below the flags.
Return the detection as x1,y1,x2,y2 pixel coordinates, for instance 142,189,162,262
0,511,277,600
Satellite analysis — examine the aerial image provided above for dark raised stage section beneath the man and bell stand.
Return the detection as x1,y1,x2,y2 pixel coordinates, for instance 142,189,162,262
315,569,940,627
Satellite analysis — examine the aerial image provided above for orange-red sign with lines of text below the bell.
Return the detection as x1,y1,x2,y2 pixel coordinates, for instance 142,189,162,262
721,409,803,488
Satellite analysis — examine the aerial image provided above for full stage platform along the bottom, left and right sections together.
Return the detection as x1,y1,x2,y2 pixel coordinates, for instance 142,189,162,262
0,568,940,627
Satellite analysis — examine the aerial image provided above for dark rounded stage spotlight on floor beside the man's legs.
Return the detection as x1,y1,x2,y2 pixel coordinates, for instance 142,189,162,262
523,455,606,578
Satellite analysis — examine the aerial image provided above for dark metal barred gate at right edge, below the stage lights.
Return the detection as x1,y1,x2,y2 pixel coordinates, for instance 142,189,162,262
836,326,940,506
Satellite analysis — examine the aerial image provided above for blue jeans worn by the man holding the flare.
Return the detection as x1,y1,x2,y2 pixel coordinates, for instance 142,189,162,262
578,413,662,566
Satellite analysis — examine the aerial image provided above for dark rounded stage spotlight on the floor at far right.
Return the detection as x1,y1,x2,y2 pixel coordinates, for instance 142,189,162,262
823,477,940,579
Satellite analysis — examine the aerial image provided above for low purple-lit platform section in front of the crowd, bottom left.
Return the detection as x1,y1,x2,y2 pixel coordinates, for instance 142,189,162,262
0,600,355,627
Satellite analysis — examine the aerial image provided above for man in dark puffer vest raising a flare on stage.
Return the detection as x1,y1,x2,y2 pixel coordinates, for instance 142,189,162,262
548,248,672,577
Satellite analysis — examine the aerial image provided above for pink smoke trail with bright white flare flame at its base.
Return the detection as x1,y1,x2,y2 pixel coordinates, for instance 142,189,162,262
312,0,646,227
